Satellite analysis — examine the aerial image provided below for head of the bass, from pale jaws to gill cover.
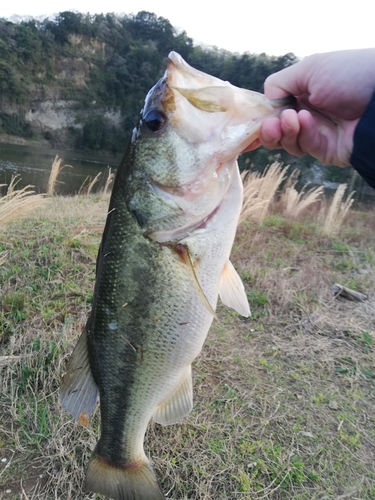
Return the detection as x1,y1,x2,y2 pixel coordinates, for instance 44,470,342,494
127,52,292,242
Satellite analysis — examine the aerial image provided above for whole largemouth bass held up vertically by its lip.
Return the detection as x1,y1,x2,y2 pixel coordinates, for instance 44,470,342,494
61,52,296,500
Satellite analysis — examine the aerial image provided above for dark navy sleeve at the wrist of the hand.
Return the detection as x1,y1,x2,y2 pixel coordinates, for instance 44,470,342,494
350,93,375,189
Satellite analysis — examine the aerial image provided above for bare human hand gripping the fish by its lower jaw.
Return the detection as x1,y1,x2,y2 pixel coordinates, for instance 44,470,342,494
259,49,375,167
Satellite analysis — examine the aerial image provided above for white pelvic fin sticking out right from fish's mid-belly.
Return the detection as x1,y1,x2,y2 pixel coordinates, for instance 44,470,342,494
219,260,251,318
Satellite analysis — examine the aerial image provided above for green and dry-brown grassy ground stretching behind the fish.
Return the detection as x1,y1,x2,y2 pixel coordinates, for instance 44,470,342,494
0,188,375,500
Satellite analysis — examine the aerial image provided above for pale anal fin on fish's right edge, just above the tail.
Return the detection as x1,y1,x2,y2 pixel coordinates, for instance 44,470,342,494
154,365,193,425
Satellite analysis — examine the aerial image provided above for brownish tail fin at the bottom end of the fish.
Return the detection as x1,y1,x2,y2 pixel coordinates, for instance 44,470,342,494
85,451,165,500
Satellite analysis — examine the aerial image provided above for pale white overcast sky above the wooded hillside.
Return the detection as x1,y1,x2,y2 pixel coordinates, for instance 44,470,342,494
0,0,375,57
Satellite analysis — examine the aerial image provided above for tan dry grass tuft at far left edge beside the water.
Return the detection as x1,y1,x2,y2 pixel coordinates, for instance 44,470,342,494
0,176,46,225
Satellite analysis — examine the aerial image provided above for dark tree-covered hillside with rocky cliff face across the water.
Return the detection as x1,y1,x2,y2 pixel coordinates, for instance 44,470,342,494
0,11,364,187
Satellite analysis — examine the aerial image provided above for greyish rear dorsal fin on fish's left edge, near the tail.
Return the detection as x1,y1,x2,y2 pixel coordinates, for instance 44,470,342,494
60,329,98,427
